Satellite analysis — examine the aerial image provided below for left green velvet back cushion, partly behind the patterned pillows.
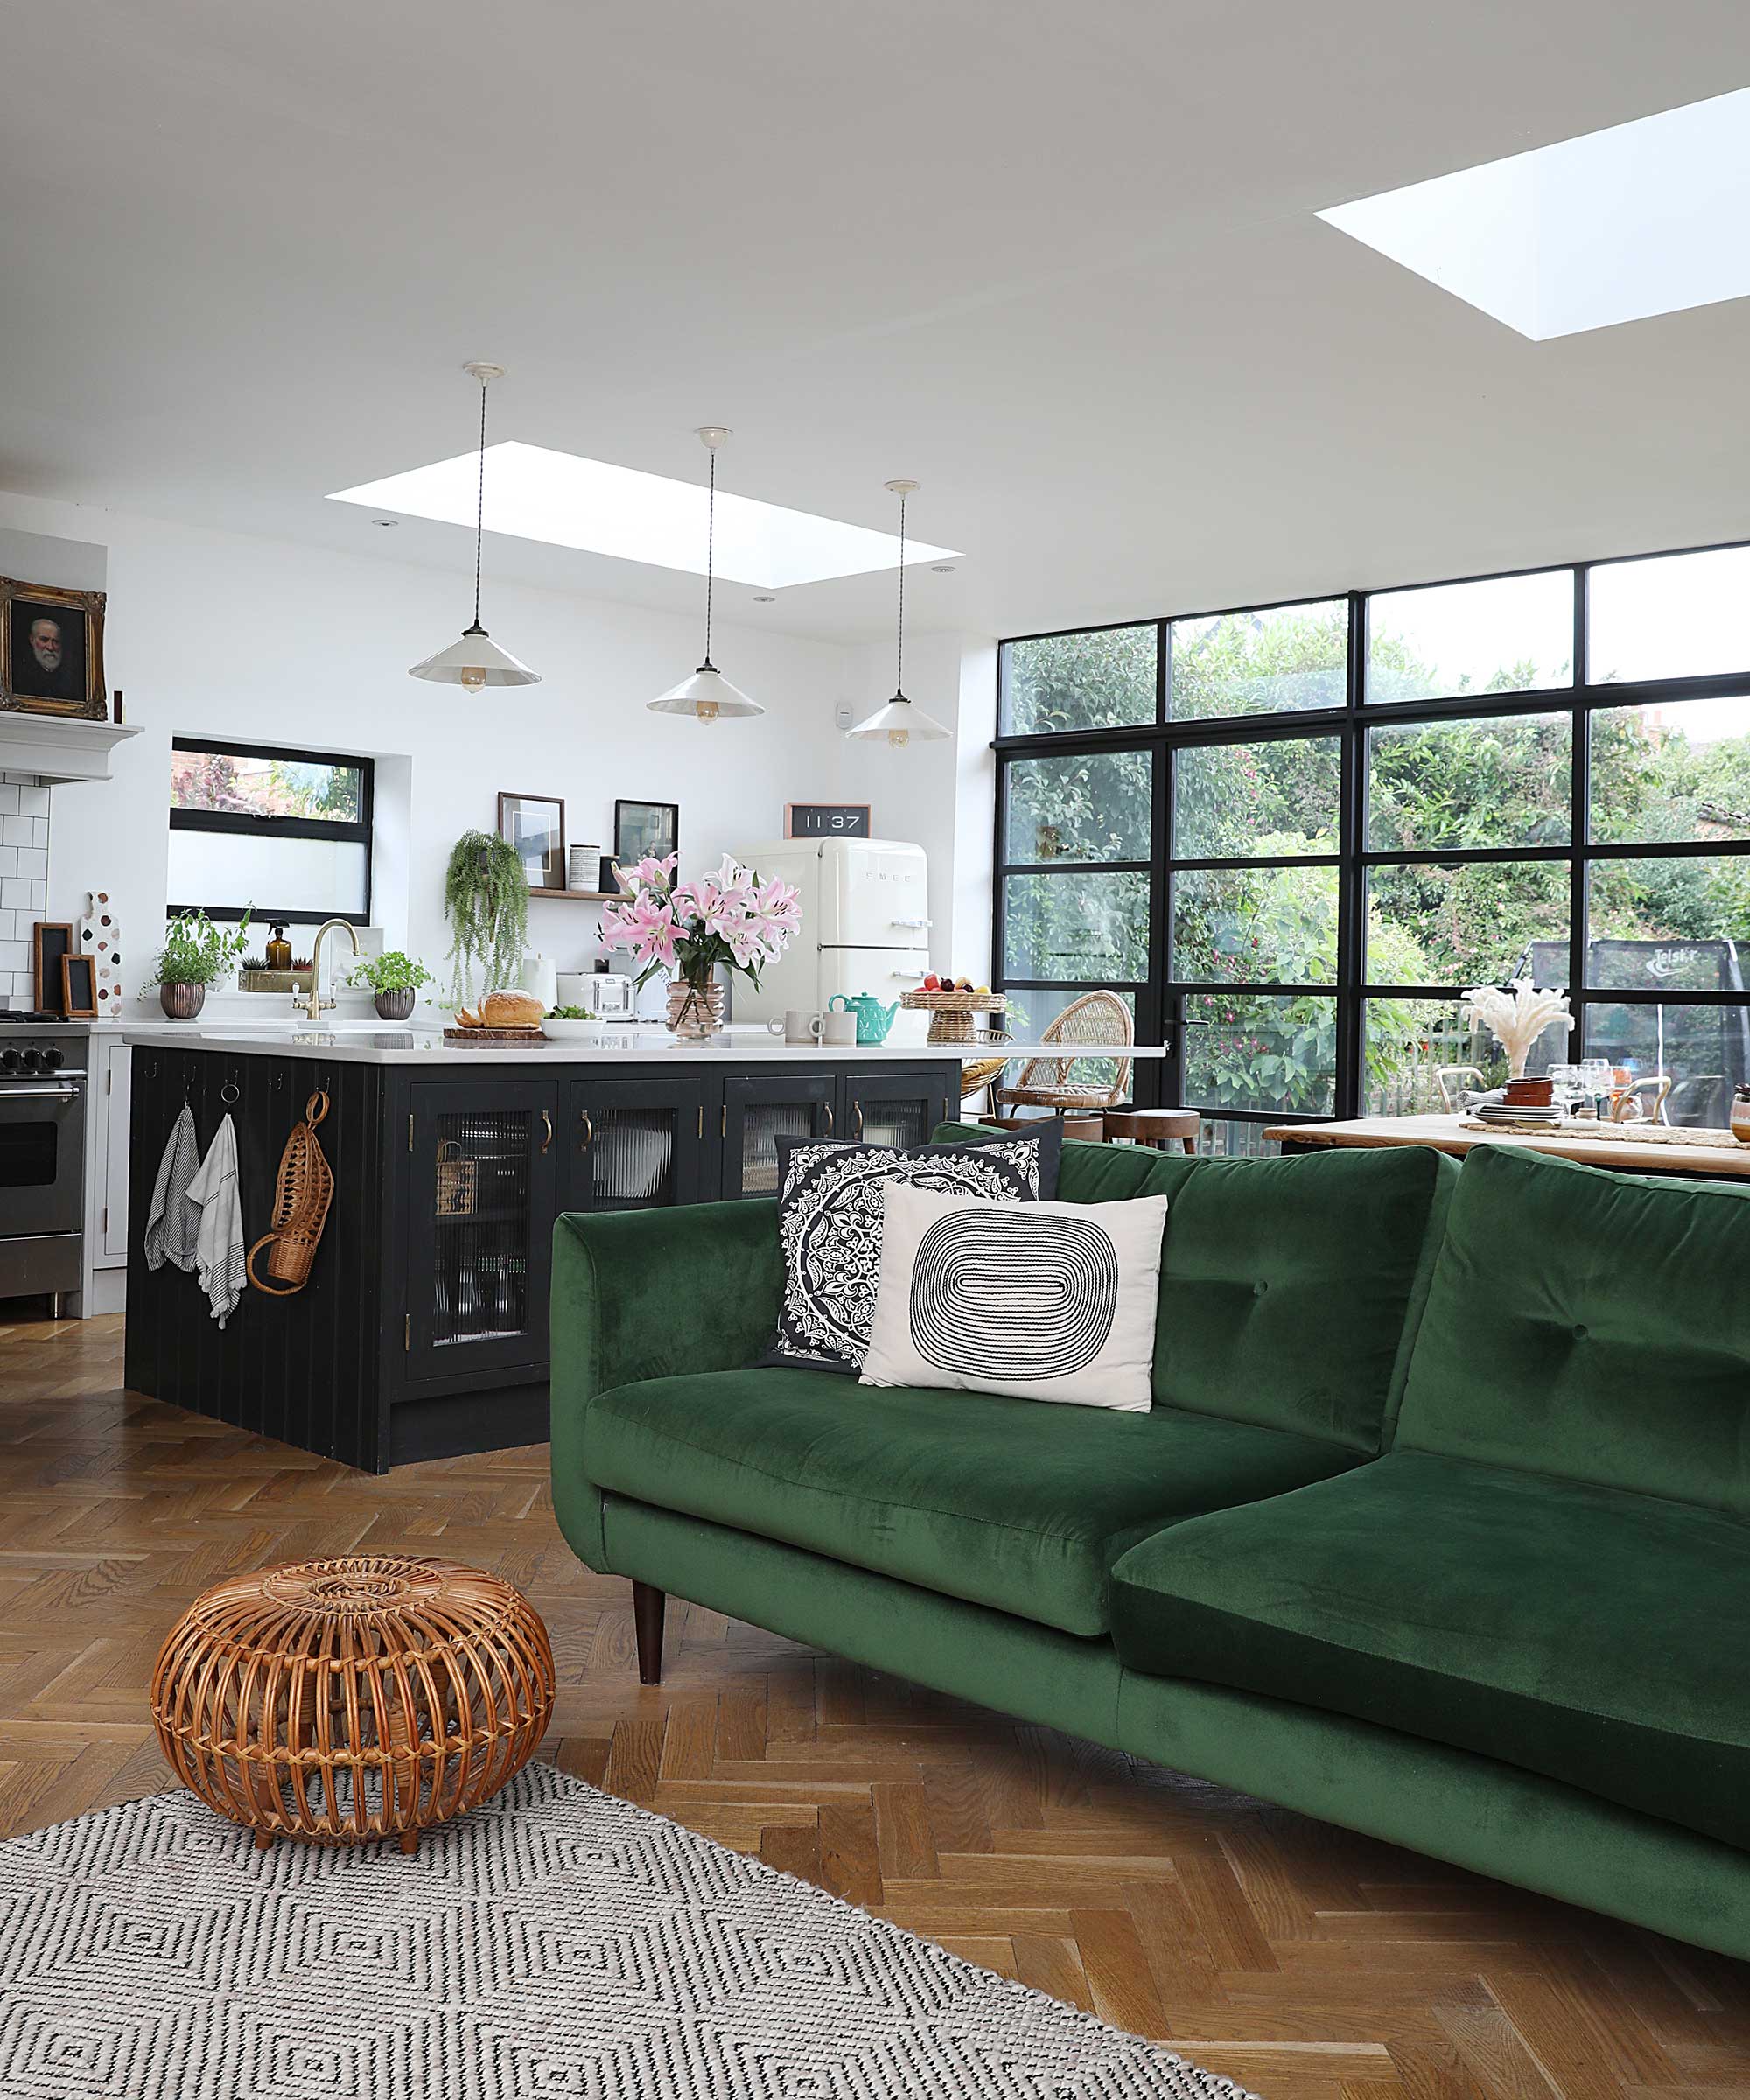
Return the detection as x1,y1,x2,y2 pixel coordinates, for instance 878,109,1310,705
937,1132,1458,1453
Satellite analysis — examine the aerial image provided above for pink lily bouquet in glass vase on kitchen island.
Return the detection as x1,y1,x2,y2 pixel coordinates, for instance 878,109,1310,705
601,852,802,1038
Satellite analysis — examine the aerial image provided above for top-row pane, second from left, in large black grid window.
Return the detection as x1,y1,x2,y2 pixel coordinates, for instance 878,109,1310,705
1166,598,1348,723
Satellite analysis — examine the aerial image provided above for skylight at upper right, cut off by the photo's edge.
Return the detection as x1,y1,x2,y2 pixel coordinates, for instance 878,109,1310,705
1317,88,1750,342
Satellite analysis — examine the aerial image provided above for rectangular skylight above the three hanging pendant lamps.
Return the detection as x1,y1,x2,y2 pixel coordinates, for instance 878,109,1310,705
330,443,956,590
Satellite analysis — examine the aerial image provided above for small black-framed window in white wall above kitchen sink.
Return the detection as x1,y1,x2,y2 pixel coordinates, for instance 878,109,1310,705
168,737,374,926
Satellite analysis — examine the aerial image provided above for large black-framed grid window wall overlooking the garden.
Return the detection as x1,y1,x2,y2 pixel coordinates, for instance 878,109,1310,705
991,546,1750,1153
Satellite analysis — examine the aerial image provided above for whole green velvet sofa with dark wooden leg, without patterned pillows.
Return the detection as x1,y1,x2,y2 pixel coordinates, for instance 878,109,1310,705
552,1125,1750,1957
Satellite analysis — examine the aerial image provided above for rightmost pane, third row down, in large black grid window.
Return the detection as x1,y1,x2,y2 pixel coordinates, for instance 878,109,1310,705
1586,852,1750,991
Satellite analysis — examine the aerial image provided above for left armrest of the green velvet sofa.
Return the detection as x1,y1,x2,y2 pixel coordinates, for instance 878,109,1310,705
550,1201,784,1569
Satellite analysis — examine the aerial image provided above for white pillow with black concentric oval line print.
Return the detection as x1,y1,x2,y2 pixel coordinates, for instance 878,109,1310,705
861,1182,1166,1413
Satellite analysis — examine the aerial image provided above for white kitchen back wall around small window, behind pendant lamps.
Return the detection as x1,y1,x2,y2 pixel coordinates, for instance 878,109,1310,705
0,494,857,1012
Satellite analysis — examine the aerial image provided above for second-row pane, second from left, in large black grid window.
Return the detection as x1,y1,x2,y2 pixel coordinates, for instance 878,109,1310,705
1172,737,1342,861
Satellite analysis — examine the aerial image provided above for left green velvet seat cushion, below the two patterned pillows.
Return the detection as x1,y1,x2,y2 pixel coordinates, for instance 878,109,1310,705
584,1369,1353,1634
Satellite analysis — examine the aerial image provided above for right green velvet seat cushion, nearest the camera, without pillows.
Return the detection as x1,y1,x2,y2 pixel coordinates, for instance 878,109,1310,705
1111,1451,1750,1846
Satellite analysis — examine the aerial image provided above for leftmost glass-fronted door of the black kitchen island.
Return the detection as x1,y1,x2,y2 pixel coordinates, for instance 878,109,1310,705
405,1082,559,1377
